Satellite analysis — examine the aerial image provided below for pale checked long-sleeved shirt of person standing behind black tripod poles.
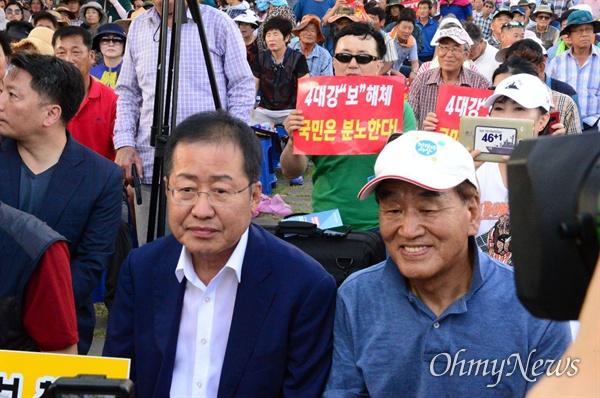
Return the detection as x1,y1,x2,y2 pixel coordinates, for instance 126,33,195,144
113,5,255,184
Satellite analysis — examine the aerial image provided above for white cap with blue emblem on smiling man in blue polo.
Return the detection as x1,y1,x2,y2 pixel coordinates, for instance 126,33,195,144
358,131,479,200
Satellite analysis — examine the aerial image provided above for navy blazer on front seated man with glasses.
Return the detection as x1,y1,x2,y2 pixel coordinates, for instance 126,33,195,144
104,224,336,398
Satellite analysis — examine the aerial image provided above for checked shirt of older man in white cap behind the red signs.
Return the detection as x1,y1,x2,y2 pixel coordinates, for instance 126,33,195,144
408,66,489,130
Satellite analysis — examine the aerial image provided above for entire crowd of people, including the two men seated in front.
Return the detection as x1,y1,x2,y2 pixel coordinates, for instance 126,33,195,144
0,0,600,397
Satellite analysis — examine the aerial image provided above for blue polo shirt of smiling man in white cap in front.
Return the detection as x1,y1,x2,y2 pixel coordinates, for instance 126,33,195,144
323,238,578,398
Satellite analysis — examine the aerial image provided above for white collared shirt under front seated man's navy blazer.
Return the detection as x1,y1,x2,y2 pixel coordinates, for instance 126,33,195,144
170,230,248,398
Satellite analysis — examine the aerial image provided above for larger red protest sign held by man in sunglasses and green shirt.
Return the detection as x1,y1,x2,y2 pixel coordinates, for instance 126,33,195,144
293,76,405,155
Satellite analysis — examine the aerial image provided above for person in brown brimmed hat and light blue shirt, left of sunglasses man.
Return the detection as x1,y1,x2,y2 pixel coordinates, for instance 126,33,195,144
289,14,332,77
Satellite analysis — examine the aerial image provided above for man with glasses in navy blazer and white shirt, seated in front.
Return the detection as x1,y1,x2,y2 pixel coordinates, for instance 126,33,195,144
104,112,336,398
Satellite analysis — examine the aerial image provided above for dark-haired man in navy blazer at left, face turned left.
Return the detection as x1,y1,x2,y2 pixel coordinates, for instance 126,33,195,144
0,54,123,354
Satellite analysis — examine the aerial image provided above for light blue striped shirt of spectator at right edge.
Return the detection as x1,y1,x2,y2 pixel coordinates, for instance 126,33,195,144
546,46,600,126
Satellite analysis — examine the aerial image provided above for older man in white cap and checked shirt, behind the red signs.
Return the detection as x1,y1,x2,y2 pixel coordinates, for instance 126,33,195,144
408,28,489,131
